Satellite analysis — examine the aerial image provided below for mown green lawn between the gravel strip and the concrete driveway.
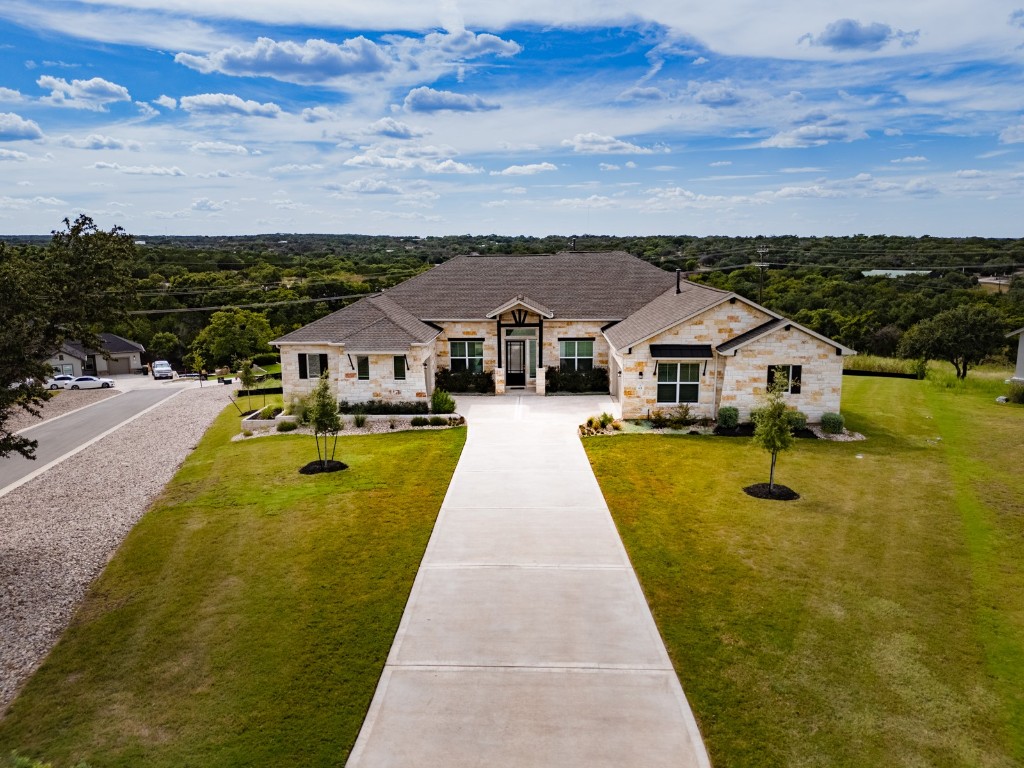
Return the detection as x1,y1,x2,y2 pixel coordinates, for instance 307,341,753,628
0,409,465,768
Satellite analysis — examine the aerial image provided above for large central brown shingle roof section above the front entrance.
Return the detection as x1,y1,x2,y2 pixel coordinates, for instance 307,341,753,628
386,251,675,321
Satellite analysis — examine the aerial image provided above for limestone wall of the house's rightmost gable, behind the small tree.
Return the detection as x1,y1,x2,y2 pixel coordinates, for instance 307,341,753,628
719,326,843,422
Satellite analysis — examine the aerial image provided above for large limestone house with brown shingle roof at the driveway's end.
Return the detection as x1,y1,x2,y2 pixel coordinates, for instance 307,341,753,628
270,252,855,421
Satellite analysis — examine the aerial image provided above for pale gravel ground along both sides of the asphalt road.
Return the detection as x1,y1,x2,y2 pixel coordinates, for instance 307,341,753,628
0,387,229,714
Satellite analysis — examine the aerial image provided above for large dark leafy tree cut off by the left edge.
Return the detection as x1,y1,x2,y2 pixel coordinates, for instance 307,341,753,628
0,215,135,459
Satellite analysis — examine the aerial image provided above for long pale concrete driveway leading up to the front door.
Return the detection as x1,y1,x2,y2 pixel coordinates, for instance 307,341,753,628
347,395,710,768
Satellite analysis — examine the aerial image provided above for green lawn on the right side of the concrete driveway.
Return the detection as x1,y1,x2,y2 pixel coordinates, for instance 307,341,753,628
585,373,1024,768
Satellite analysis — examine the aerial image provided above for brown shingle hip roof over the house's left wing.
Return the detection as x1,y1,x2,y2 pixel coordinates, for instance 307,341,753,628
270,296,439,352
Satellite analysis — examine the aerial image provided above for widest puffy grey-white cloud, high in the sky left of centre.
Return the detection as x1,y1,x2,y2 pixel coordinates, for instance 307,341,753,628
174,35,391,84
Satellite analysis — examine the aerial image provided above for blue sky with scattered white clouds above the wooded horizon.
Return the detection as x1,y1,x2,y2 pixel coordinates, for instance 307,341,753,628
0,0,1024,237
